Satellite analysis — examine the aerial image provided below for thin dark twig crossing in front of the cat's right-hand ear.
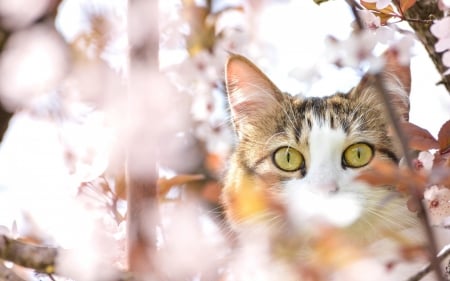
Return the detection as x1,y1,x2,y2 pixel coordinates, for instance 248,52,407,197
346,0,445,281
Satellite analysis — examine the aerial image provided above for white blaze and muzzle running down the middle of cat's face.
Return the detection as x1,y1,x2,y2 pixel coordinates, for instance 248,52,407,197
284,120,363,227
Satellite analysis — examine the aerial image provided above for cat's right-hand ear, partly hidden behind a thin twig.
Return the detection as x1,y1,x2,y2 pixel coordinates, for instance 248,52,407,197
350,50,411,121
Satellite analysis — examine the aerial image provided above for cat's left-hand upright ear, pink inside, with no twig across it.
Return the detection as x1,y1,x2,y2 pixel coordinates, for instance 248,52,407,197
225,55,283,137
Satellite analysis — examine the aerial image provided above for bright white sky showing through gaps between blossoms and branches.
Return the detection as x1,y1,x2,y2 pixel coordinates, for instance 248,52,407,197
0,0,450,236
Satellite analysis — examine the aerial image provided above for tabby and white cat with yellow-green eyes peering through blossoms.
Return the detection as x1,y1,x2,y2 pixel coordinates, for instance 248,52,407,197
222,52,440,281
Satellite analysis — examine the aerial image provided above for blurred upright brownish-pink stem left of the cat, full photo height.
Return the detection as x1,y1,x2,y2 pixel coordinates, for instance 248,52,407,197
126,0,161,280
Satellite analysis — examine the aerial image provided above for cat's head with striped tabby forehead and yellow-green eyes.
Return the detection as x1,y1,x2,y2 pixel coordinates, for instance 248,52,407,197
223,53,410,236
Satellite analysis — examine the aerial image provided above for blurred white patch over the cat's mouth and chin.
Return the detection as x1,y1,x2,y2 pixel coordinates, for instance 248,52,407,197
282,180,364,230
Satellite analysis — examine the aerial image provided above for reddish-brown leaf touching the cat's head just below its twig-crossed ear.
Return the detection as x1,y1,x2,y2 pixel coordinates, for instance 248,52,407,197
402,122,439,151
